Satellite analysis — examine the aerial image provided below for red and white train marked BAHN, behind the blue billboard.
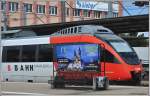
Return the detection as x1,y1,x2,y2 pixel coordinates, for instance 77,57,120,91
2,25,142,83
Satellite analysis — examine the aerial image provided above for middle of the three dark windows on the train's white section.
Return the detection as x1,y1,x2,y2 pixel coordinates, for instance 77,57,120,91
22,45,36,62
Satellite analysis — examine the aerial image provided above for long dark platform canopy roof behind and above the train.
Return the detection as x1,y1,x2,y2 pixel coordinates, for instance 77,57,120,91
9,14,149,35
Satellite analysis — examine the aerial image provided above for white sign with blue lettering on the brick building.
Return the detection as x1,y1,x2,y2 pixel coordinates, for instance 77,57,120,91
75,0,118,12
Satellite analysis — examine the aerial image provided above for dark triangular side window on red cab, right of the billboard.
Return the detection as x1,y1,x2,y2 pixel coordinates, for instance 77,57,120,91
101,49,120,64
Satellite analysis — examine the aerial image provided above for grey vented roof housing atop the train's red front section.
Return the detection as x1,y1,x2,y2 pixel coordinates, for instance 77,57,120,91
52,25,113,36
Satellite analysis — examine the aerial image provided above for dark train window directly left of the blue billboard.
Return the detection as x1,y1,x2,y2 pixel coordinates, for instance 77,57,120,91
38,44,53,62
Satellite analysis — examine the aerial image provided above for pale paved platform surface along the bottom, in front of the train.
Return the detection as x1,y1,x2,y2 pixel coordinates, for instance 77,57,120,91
1,82,149,96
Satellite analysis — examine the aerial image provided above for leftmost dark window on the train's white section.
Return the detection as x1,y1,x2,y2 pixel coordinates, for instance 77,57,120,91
2,46,21,62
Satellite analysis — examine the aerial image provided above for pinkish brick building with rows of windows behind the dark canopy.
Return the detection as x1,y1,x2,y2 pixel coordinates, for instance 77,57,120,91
0,0,122,30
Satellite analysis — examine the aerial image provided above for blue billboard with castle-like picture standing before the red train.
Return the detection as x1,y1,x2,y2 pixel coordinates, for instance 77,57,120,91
55,44,100,71
